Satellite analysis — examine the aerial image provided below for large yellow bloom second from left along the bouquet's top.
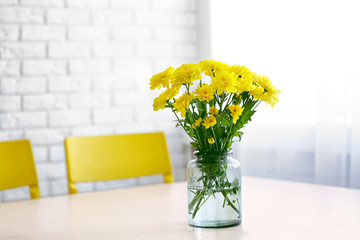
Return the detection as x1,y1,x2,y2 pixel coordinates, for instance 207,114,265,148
170,63,201,87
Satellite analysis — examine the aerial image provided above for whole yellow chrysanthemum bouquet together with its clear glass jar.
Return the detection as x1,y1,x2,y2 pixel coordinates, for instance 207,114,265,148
150,60,280,227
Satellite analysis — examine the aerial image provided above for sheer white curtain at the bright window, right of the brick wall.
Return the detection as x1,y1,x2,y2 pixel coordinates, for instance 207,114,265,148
207,0,360,188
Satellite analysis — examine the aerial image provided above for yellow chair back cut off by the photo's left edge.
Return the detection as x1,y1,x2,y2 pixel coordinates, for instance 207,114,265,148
0,140,40,199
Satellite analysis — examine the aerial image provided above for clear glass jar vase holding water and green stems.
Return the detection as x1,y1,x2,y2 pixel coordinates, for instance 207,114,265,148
187,152,241,228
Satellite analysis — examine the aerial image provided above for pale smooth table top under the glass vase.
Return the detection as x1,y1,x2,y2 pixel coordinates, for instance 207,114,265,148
0,177,360,240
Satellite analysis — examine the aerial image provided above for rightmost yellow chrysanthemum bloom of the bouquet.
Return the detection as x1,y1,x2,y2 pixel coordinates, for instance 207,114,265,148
250,74,280,107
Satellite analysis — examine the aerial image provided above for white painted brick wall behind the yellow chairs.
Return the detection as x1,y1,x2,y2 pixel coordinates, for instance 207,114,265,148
0,0,198,202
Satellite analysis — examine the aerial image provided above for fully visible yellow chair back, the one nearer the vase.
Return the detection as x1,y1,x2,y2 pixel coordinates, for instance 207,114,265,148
65,133,174,194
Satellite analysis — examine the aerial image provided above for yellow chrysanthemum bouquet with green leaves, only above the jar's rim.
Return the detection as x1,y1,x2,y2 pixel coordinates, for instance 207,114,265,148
150,60,280,153
